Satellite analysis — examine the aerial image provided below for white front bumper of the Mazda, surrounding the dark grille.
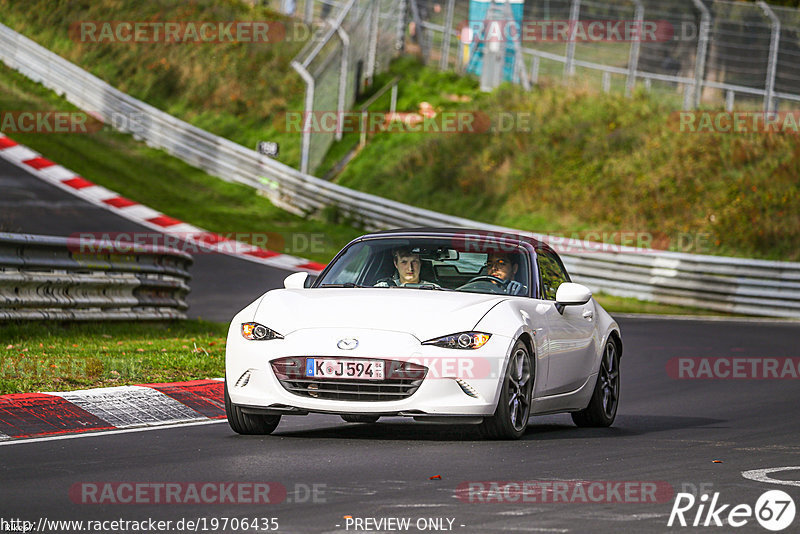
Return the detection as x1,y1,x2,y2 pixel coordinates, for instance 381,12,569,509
226,324,513,417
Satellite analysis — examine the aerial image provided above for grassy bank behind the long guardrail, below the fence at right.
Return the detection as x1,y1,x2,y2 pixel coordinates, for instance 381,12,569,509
337,61,800,261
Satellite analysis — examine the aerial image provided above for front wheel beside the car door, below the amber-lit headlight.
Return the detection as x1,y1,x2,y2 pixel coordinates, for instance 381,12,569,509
480,340,534,439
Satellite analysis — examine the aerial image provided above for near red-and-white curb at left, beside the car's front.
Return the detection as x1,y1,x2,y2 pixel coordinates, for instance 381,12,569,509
0,379,225,442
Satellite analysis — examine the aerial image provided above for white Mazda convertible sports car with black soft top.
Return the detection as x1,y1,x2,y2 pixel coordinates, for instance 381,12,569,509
225,229,622,439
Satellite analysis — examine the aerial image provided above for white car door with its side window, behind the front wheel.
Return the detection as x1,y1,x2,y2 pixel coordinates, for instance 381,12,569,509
536,249,597,395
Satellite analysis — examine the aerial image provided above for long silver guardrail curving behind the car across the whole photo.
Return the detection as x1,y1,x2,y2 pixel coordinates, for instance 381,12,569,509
0,25,800,318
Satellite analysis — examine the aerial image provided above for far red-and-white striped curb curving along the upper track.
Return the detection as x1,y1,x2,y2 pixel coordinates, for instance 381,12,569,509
0,134,325,273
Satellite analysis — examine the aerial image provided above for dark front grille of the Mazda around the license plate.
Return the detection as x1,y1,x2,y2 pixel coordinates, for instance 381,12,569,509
271,357,428,402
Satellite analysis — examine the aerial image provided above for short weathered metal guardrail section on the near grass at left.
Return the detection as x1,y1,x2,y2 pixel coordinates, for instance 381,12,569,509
0,232,192,320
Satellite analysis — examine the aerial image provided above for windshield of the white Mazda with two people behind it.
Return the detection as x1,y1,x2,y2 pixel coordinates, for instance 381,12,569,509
314,236,530,296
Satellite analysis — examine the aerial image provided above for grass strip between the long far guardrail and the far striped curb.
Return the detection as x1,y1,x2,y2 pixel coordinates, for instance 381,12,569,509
0,65,360,263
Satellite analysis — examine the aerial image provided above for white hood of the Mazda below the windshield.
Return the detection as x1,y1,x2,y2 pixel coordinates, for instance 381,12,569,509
253,288,508,341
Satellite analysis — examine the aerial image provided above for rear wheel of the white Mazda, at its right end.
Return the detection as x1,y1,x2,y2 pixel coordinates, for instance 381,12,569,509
572,339,619,427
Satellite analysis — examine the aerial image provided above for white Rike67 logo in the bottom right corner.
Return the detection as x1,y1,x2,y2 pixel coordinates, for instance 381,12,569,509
667,490,795,532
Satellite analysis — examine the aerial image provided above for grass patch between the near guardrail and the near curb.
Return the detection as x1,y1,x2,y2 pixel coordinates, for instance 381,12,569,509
0,320,227,395
